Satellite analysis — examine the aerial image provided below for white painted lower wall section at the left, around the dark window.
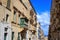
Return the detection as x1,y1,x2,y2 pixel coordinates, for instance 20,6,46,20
0,22,11,40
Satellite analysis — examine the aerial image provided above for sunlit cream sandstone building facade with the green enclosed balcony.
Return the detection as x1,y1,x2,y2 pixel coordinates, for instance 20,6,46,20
0,0,37,40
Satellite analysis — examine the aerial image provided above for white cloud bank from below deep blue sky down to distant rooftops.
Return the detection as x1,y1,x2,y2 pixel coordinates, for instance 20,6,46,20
37,11,50,34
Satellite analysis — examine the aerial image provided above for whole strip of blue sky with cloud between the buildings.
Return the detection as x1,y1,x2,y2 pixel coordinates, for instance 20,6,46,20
31,0,51,35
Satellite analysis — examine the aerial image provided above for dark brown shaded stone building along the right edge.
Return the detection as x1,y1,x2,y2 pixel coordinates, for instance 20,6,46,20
48,0,60,40
